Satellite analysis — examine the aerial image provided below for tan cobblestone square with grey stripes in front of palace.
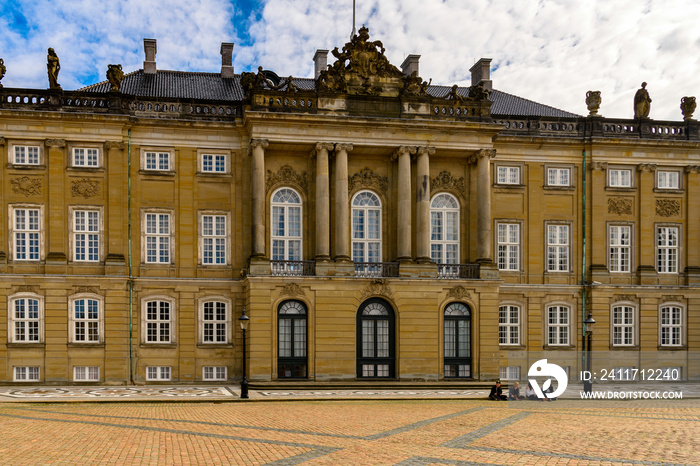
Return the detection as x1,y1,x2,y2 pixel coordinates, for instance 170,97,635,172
0,399,700,466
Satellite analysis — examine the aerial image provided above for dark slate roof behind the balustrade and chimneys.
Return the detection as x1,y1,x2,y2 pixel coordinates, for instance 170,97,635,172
78,70,580,118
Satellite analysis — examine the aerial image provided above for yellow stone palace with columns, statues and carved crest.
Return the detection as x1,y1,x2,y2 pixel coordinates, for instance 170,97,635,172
0,28,700,384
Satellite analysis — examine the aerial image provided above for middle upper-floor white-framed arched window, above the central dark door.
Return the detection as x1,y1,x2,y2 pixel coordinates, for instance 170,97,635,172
352,191,382,262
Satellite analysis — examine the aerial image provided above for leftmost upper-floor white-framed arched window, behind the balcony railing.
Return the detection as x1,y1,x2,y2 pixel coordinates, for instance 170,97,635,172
270,188,302,261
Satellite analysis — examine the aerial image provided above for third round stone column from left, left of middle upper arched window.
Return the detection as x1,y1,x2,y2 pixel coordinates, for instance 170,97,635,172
335,144,352,261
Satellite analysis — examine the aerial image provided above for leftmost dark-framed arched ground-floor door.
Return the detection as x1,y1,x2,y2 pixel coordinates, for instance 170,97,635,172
277,301,308,379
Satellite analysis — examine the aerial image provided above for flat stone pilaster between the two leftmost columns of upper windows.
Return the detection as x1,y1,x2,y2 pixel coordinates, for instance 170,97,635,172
45,139,71,262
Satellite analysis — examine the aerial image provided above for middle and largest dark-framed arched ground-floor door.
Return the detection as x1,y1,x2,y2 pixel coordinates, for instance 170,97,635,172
357,298,395,378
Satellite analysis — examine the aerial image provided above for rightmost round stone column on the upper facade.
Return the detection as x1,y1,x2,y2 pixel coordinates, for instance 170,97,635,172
475,149,496,262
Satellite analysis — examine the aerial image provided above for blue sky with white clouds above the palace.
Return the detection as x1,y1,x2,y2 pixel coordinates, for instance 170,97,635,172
0,0,700,121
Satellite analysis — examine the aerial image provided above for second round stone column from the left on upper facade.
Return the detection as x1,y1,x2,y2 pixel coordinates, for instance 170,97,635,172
315,142,333,261
